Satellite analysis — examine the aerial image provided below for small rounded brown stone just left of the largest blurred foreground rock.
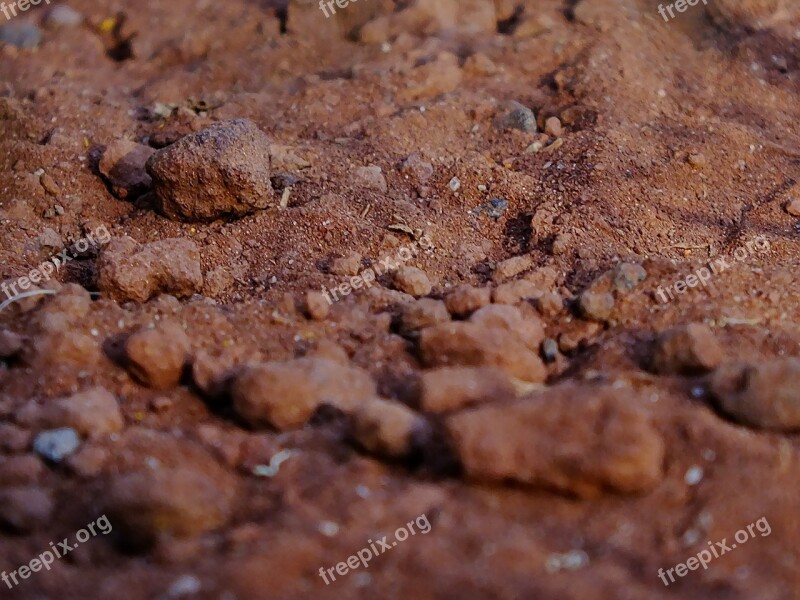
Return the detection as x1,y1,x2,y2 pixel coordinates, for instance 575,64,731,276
353,398,432,458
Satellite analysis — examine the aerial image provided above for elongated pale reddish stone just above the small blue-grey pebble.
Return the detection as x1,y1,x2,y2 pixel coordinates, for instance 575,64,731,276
17,387,124,437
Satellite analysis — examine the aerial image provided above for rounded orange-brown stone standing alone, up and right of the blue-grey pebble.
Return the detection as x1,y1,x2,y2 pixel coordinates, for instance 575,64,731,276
124,322,191,390
